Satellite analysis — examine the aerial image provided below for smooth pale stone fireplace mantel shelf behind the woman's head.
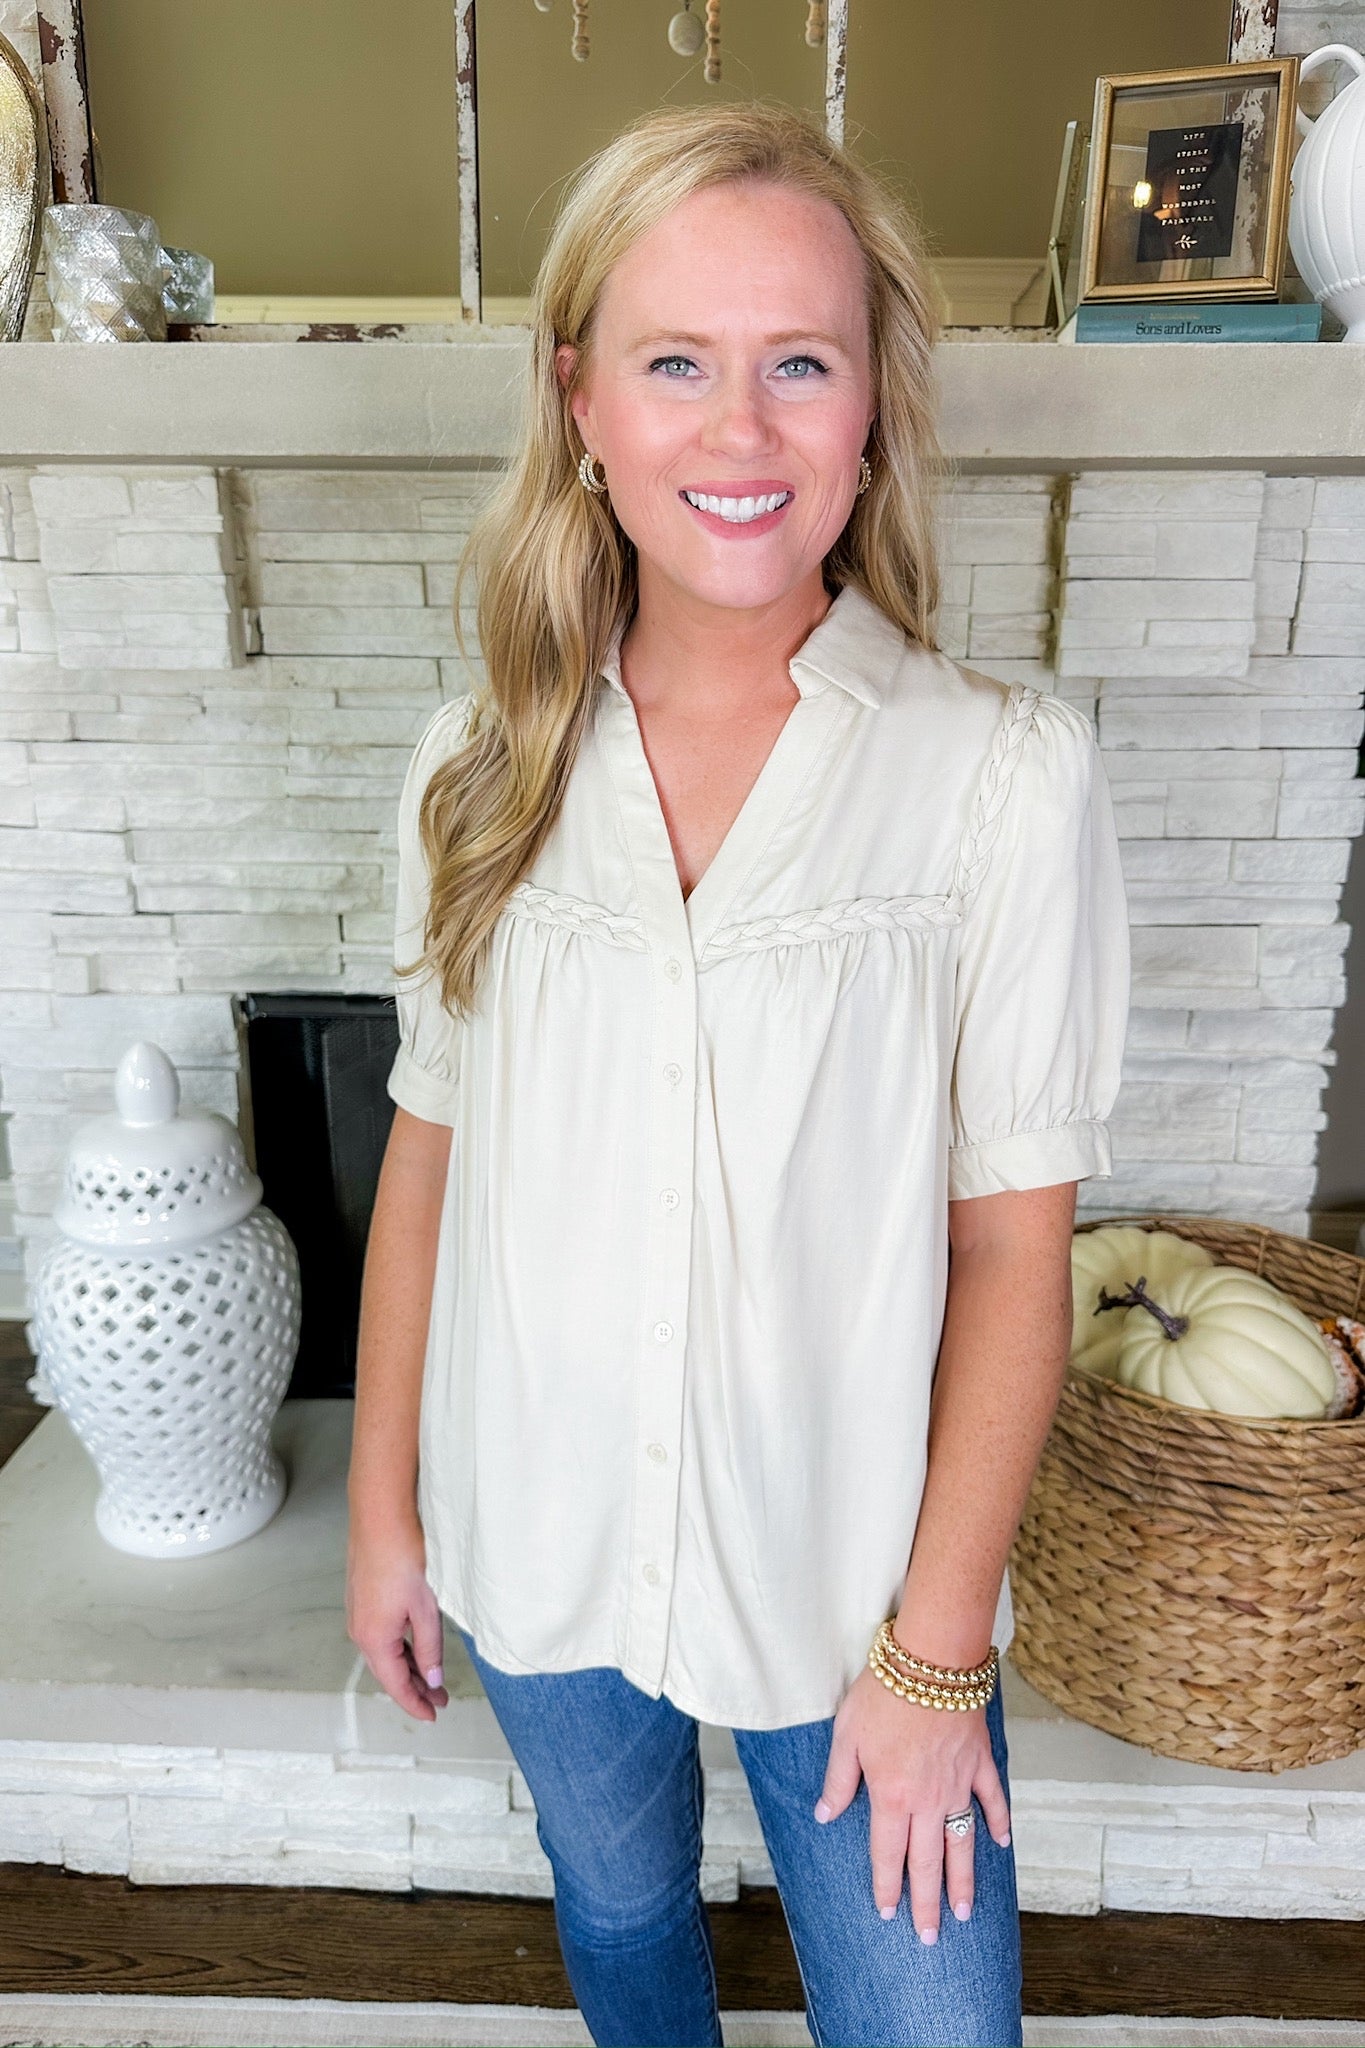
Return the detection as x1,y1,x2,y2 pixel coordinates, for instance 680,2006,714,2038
0,328,1365,475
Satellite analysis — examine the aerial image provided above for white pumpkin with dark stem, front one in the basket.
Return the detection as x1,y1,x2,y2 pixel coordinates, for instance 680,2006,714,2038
1111,1264,1336,1421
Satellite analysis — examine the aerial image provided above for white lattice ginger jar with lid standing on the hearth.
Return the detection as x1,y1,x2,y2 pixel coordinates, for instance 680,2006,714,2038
31,1042,301,1559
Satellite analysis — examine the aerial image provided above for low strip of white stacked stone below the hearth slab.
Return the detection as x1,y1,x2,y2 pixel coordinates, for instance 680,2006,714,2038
0,1741,1365,1919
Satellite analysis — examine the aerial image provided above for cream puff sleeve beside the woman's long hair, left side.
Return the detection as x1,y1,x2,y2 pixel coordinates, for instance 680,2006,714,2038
387,696,471,1124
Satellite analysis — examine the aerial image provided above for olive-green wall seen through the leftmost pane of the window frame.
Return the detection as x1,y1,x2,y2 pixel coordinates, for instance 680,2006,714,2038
84,0,460,295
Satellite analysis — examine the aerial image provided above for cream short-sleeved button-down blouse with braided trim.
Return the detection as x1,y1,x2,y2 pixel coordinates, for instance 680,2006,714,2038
389,586,1128,1729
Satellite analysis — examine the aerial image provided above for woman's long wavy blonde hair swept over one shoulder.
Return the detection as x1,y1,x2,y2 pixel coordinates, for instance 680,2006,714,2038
399,100,945,1014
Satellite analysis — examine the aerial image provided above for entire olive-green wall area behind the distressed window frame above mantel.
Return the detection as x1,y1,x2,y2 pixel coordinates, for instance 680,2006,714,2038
84,0,1230,295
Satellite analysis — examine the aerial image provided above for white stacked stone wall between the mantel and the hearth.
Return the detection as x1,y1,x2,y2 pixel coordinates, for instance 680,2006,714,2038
0,465,1365,1294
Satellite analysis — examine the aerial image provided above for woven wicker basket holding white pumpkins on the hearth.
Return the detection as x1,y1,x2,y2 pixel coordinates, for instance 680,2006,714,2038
1009,1214,1365,1772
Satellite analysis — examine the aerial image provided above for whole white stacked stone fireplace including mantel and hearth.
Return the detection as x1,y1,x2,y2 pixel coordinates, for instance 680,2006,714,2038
0,330,1365,1917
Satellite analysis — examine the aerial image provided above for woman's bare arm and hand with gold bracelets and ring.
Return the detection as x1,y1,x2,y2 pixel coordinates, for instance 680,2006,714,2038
814,1182,1076,1942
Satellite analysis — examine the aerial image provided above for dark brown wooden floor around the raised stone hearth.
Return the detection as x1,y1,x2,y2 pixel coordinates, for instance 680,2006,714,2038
0,1323,1365,2019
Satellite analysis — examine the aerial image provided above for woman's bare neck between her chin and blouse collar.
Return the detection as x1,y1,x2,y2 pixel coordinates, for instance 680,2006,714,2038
620,561,831,719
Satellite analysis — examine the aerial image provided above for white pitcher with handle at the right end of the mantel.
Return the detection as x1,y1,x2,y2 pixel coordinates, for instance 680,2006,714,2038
1289,43,1365,342
